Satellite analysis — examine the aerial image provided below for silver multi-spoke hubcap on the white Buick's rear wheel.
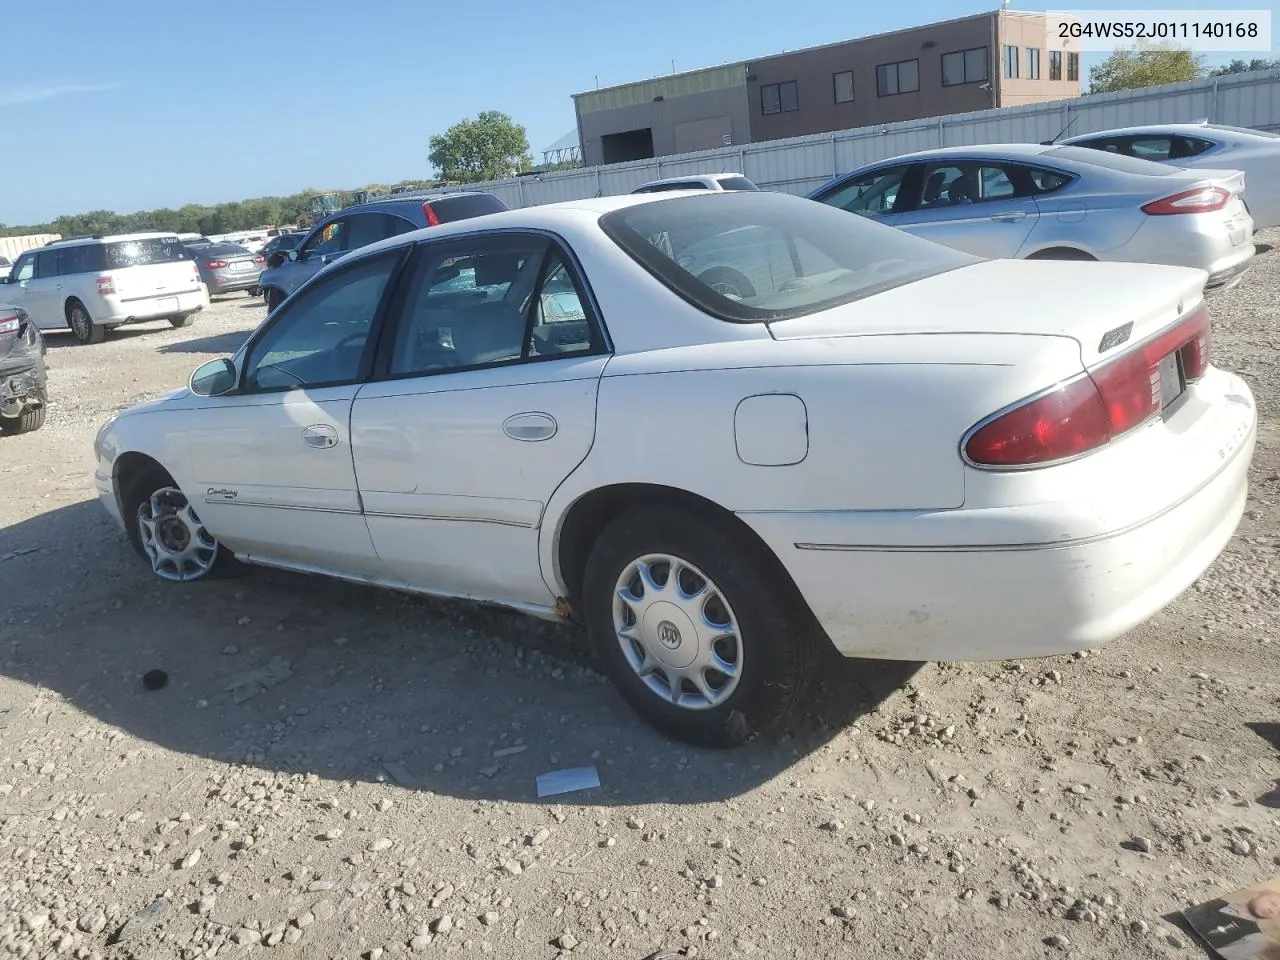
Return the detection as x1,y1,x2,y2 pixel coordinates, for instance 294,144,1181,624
613,554,742,710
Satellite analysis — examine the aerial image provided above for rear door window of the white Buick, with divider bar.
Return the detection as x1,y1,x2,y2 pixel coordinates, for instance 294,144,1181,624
389,237,599,376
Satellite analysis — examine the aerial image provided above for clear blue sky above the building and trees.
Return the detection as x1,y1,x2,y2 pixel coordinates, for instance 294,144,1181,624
0,0,1257,224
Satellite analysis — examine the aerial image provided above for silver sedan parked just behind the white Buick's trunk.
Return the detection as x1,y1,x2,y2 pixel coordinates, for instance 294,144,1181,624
809,143,1254,291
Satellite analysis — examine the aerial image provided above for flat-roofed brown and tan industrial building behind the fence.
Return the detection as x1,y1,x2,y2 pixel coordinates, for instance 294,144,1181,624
573,10,1080,166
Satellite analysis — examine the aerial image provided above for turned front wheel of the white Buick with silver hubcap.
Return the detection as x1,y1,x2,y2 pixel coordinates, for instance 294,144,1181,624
122,468,238,582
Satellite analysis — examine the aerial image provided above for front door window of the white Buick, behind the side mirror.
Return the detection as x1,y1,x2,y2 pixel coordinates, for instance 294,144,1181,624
244,250,403,390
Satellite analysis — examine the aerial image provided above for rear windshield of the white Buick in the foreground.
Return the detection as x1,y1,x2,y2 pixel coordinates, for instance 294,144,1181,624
600,191,979,323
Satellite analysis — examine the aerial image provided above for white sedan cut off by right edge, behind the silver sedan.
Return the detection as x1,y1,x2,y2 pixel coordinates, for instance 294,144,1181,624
1059,122,1280,230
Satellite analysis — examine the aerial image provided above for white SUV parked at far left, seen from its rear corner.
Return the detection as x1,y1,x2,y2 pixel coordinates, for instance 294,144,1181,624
0,233,209,343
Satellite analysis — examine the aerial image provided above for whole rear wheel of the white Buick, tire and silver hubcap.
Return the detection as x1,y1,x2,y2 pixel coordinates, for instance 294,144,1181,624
582,509,815,746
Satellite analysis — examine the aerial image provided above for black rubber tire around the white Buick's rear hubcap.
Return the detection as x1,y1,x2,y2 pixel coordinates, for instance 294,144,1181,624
581,508,819,748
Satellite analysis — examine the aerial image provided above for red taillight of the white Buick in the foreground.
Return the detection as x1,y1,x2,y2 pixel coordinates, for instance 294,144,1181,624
964,307,1210,467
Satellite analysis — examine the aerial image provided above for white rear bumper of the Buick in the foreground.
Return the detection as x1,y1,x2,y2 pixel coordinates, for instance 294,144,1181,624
741,371,1257,660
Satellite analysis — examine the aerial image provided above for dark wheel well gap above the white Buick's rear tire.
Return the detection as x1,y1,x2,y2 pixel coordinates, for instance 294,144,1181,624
556,484,808,619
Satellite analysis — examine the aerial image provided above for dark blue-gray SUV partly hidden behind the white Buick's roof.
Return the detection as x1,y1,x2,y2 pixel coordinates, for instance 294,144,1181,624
260,192,507,311
